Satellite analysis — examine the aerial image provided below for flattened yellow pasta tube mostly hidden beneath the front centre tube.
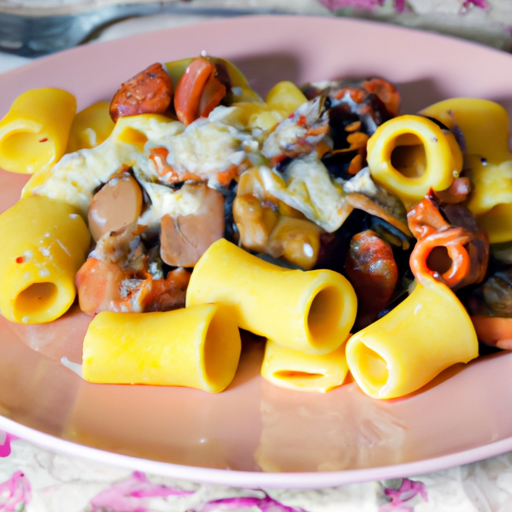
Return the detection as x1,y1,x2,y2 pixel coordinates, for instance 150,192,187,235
261,340,348,393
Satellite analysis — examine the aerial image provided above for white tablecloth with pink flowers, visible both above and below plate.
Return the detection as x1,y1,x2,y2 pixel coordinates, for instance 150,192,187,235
0,0,512,512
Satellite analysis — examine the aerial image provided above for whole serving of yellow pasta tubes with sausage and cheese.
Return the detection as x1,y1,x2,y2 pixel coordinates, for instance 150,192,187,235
0,55,506,399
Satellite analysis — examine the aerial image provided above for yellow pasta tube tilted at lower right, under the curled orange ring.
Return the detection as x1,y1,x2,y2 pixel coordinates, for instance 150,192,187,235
346,278,478,398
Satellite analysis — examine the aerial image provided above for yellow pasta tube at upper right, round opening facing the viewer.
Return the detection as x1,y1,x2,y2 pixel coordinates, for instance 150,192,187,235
368,115,462,205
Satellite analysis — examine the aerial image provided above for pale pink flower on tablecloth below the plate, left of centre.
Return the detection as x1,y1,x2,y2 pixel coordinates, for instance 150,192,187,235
90,471,195,512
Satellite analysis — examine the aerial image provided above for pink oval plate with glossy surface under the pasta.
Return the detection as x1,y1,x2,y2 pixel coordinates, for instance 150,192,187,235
0,16,512,488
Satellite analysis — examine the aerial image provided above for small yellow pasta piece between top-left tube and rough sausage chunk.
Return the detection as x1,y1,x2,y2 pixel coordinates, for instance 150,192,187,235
66,101,114,153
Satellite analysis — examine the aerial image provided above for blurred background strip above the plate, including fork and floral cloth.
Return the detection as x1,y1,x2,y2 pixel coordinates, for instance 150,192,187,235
0,0,512,60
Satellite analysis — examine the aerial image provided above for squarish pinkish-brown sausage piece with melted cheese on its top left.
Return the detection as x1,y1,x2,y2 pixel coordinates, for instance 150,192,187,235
160,183,225,267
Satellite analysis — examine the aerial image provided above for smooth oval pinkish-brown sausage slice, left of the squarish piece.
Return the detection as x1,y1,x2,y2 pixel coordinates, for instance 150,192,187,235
88,173,143,242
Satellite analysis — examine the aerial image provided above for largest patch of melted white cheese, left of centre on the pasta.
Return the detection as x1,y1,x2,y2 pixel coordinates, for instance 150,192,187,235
23,112,257,226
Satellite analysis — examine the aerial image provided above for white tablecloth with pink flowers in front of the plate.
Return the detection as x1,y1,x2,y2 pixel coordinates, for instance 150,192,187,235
0,432,512,512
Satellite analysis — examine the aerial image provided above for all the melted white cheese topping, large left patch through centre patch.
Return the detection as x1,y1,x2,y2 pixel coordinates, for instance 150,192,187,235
23,102,352,232
